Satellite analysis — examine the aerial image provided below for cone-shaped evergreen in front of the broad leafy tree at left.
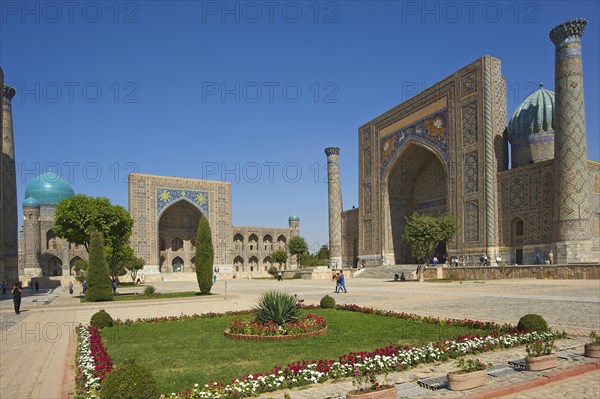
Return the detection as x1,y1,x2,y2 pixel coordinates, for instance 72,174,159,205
85,231,113,302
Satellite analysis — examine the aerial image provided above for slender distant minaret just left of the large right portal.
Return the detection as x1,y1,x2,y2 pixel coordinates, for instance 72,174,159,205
325,147,342,269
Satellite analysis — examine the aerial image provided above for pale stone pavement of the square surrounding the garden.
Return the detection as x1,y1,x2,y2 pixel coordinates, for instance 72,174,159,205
0,279,600,399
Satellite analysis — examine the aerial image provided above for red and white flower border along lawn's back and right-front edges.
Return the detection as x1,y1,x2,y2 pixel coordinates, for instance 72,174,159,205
82,305,560,399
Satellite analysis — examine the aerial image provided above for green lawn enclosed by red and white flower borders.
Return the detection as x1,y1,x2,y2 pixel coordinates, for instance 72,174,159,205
102,309,485,393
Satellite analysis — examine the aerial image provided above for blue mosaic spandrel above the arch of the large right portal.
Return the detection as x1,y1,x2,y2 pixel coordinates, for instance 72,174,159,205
380,109,449,176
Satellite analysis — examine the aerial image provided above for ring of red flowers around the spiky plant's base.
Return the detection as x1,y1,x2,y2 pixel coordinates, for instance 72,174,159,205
229,313,327,337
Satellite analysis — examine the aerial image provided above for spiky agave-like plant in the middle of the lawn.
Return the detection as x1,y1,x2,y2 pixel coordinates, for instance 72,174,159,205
254,291,300,325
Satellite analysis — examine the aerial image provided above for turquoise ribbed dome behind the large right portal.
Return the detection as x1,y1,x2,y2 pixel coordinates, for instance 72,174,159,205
508,84,554,144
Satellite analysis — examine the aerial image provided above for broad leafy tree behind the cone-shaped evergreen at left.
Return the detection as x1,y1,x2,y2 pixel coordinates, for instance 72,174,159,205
52,194,133,279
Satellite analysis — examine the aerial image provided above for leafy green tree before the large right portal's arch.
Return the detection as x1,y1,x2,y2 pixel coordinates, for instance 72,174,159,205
402,212,457,281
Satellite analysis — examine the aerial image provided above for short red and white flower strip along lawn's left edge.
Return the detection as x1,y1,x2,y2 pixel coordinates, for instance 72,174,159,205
75,326,113,397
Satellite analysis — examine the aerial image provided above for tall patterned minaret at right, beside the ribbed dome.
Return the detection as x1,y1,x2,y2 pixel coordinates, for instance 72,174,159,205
550,19,592,264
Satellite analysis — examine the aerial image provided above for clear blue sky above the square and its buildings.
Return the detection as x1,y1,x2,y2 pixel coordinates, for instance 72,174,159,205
0,0,600,250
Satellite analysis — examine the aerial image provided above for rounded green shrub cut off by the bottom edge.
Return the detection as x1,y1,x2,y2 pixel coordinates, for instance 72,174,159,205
100,360,160,399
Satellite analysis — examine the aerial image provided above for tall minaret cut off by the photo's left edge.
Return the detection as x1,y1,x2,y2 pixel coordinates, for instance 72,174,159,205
2,85,18,282
